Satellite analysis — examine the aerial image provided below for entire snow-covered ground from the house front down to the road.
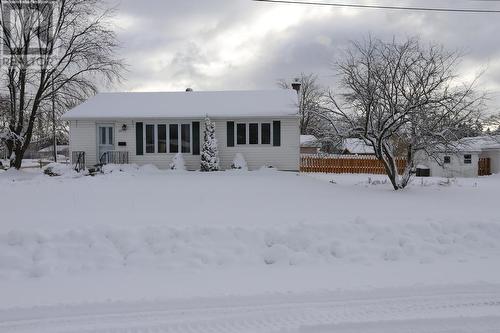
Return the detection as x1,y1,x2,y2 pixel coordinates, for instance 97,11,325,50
0,166,500,333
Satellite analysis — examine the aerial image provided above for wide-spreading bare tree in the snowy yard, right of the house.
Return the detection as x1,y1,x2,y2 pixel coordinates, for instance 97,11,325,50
320,38,484,190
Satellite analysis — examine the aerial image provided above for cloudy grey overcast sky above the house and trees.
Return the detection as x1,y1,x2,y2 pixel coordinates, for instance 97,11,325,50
111,0,500,110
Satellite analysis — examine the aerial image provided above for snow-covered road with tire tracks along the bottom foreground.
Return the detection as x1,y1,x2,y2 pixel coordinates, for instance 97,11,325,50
0,286,500,333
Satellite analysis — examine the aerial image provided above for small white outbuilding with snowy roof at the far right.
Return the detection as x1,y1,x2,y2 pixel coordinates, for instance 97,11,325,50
417,136,500,178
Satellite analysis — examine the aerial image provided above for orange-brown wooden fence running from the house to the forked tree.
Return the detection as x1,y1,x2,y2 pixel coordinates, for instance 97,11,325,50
300,155,406,175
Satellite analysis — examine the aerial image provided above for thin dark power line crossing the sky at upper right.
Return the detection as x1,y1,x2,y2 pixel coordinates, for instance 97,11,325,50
251,0,500,14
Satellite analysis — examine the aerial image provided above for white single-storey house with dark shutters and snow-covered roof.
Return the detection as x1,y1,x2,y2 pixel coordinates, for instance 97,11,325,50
63,90,300,171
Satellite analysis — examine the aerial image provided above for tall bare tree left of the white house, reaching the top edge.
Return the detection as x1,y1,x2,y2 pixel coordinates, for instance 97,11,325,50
0,0,123,168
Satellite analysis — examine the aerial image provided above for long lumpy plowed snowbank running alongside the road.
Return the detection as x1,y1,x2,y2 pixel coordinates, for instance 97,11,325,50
0,219,500,278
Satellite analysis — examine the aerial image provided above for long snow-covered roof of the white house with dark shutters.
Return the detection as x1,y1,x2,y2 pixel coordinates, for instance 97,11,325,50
62,89,297,120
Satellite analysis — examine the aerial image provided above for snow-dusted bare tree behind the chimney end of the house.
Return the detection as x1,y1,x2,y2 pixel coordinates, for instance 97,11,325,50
278,73,325,135
